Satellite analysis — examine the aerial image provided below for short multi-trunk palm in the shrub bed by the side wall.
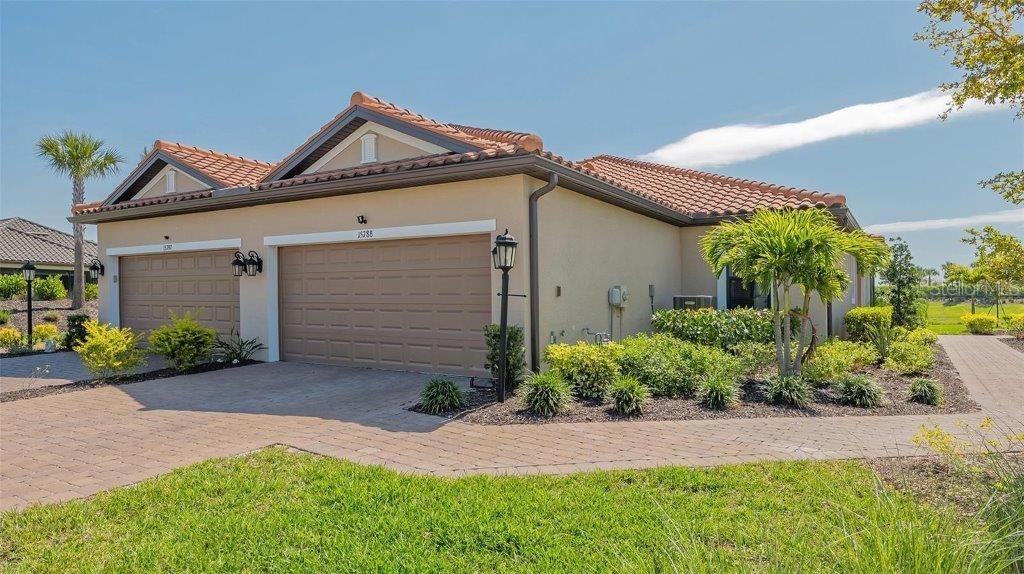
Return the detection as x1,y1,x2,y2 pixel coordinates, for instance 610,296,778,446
700,209,889,374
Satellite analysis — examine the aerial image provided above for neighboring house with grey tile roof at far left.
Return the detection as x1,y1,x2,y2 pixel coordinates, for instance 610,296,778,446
0,217,97,291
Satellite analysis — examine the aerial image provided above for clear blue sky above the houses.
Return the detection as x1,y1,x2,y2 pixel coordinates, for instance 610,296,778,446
0,2,1024,266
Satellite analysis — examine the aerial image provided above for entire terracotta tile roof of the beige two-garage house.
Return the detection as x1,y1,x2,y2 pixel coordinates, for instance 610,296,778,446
74,92,846,221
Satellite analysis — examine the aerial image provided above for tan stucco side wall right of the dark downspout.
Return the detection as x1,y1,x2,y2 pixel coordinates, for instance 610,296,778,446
539,187,683,344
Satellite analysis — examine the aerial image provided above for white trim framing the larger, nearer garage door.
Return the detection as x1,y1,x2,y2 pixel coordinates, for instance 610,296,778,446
263,219,498,361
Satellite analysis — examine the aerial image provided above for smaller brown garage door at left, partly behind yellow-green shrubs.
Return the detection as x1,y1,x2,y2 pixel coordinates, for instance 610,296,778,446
118,251,239,334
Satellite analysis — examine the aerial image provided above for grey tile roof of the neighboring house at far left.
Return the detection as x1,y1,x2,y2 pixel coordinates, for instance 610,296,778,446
0,217,96,265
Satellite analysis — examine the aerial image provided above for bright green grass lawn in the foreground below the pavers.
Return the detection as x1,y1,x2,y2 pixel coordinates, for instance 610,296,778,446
0,448,1007,573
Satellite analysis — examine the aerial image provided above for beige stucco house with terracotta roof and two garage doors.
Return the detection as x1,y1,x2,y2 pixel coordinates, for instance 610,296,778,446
71,92,866,374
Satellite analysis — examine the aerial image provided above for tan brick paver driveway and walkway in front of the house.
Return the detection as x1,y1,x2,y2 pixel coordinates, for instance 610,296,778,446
0,337,1024,509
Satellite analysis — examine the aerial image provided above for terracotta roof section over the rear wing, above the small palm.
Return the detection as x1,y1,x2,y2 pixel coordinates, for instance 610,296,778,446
579,156,846,217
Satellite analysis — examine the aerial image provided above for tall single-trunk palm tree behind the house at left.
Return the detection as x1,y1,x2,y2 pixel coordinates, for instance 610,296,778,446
36,131,124,309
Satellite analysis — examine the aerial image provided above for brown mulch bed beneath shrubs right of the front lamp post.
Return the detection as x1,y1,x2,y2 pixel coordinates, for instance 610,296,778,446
430,346,978,425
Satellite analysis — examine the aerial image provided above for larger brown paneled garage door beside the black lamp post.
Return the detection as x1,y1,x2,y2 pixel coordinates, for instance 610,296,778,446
279,235,494,374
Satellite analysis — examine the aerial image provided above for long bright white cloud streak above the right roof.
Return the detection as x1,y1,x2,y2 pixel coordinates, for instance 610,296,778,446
640,90,1001,168
